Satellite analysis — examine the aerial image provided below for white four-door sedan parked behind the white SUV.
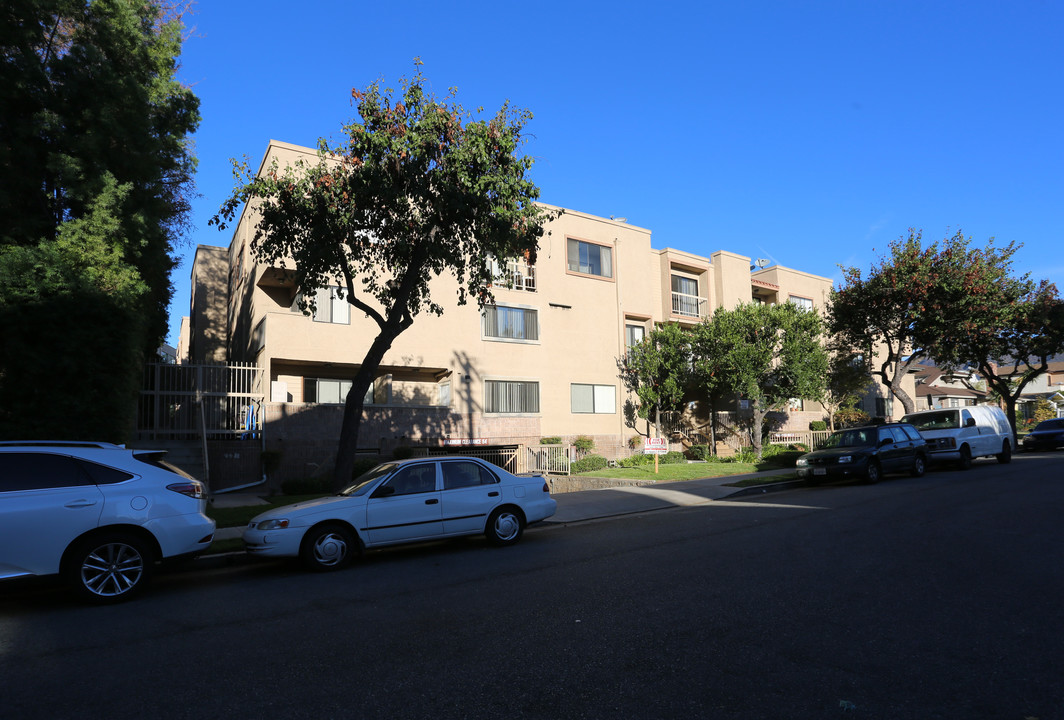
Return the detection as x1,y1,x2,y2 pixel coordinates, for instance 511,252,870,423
244,456,558,570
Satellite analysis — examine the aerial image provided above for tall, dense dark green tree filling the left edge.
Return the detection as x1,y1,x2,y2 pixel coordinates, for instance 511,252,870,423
0,0,199,439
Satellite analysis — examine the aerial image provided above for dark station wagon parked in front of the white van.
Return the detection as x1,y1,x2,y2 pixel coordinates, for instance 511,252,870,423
797,422,928,483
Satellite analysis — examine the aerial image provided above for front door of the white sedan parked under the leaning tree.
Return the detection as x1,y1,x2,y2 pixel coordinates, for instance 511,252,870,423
366,462,444,545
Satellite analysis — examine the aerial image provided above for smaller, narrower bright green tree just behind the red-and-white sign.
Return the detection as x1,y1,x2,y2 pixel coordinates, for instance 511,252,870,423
617,323,691,437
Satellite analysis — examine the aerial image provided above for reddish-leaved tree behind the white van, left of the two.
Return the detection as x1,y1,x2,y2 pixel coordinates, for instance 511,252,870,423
829,230,962,413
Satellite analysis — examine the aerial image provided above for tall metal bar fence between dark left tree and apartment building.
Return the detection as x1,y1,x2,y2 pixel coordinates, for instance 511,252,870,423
136,363,263,440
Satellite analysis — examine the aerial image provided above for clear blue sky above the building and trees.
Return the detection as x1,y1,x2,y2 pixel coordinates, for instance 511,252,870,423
163,0,1064,344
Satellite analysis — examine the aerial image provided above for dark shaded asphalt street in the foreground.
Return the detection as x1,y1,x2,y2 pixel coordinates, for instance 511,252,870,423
0,453,1064,720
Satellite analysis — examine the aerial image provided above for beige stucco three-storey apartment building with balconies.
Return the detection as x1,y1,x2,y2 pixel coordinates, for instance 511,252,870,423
188,141,902,472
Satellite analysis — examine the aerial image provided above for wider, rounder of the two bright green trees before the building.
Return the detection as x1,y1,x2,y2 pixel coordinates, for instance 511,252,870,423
694,303,828,459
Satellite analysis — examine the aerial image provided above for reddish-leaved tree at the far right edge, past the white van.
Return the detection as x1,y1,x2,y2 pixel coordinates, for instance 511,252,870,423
917,237,1064,439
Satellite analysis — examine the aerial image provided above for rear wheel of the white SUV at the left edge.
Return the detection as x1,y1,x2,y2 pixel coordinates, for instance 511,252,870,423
64,533,154,604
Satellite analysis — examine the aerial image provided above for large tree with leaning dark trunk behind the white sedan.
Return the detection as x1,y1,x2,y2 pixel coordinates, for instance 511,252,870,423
212,61,548,486
